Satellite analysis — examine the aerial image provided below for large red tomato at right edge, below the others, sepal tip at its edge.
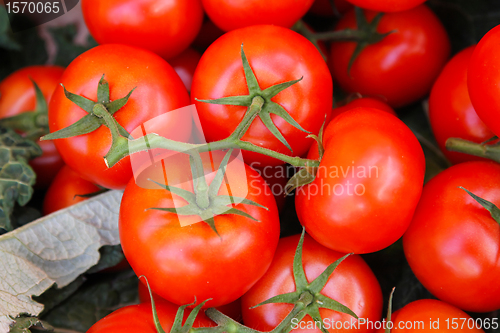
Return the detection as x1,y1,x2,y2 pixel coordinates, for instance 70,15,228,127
403,161,500,312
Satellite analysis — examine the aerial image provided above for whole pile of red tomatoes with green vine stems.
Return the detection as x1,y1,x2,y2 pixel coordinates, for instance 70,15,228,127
0,0,500,332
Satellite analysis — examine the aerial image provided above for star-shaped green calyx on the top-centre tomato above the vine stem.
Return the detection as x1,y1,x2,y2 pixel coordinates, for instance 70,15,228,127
196,44,310,151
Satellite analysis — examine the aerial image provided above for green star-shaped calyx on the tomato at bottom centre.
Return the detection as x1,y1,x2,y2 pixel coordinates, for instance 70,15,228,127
254,230,358,333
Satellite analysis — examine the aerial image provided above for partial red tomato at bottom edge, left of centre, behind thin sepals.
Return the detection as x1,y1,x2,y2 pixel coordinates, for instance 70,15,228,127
87,301,217,333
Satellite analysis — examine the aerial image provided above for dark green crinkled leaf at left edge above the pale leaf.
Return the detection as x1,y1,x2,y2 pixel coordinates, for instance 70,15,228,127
0,128,42,230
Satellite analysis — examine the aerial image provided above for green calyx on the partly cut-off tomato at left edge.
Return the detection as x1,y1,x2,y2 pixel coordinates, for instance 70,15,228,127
0,80,49,140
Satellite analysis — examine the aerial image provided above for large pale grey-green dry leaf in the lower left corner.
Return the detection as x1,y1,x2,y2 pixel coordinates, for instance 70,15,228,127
0,191,123,333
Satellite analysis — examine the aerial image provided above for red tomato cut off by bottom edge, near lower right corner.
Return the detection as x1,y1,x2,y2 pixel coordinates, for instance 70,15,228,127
377,299,491,333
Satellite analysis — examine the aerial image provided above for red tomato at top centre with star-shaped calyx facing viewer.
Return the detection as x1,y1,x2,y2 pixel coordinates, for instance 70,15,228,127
191,25,333,166
